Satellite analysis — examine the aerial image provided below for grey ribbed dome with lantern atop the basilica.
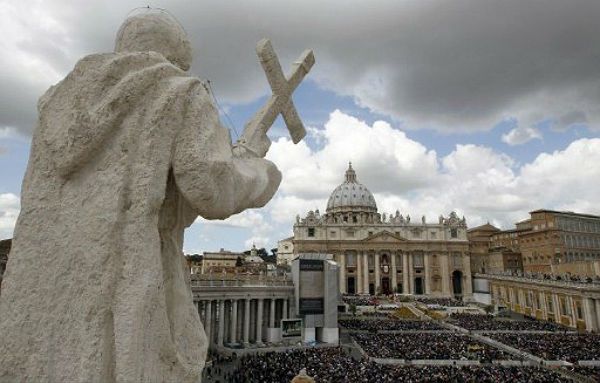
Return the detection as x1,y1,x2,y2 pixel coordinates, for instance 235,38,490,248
327,163,377,213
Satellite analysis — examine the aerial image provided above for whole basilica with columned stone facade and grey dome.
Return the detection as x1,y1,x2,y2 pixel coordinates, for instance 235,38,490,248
290,164,472,299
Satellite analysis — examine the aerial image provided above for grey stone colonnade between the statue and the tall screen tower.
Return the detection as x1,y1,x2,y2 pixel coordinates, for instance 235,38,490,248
194,297,294,347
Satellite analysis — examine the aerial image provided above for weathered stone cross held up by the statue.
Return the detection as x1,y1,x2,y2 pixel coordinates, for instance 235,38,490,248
238,39,315,156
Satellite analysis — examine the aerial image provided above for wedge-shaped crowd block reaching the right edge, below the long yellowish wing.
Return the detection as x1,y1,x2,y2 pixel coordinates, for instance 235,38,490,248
489,333,600,362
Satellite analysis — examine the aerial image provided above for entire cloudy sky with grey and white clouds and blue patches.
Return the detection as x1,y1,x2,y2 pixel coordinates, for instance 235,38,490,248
0,0,600,252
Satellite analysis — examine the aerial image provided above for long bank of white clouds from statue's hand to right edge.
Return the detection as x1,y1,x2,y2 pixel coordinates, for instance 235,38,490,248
267,111,600,232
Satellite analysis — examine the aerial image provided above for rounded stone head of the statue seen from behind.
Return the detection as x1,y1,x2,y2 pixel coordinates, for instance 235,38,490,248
115,11,192,70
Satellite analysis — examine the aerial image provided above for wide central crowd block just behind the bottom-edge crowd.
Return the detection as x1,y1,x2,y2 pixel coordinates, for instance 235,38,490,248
352,332,511,362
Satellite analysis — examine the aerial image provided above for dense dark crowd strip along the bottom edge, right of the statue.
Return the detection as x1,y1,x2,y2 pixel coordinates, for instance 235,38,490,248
227,348,569,383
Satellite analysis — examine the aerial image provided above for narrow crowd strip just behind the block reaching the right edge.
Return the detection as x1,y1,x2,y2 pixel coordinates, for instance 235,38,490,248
449,313,569,331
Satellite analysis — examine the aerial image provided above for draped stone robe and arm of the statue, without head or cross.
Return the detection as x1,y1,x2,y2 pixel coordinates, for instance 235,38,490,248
0,52,280,382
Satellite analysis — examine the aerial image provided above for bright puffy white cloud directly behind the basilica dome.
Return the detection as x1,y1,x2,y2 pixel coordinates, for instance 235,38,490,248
267,110,438,199
